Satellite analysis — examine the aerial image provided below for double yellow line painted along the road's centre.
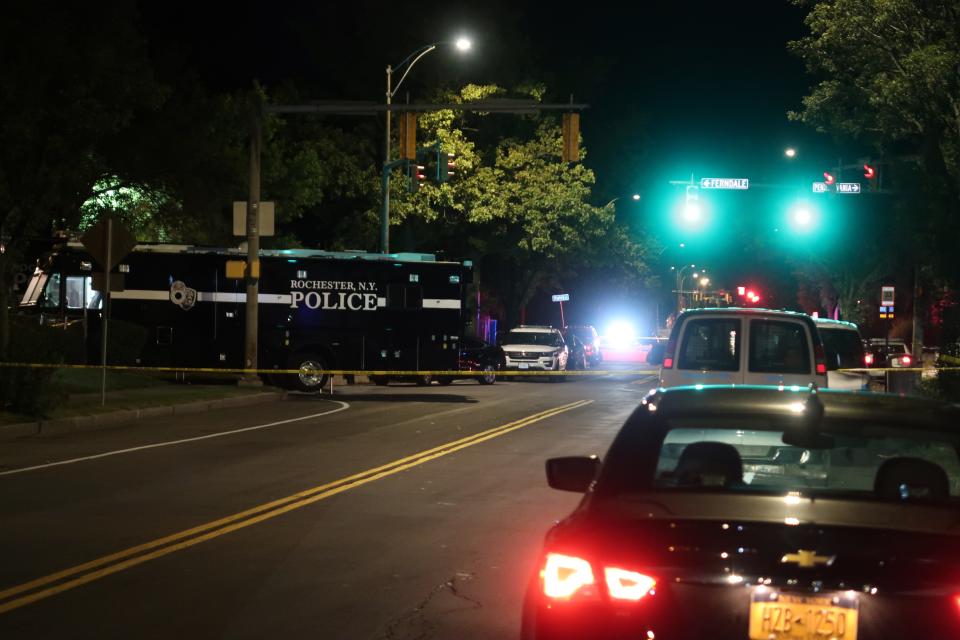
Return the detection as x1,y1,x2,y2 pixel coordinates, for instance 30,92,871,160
0,400,593,614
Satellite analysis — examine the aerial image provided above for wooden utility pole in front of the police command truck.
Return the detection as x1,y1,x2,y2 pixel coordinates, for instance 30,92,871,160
240,95,263,386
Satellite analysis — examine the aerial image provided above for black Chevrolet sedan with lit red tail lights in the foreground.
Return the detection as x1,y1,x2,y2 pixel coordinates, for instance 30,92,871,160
522,387,960,640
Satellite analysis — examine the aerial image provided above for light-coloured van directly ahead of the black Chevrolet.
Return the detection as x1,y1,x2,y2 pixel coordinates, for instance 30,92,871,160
651,308,827,388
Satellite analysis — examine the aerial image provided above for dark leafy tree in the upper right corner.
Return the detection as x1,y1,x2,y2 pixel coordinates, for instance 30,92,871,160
789,0,960,275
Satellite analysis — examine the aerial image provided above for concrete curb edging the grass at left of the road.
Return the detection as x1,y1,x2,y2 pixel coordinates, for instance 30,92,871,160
0,392,287,442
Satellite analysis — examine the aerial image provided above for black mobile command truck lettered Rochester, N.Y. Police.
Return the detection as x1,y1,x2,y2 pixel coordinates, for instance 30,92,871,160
20,243,471,390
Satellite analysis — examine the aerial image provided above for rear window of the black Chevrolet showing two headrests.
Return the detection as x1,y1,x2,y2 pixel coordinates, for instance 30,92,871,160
652,421,960,501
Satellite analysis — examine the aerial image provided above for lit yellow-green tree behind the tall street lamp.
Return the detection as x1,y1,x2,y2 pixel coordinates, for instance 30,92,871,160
380,85,647,326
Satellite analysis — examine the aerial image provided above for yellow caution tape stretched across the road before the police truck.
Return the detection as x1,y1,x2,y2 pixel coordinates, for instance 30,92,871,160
0,362,659,377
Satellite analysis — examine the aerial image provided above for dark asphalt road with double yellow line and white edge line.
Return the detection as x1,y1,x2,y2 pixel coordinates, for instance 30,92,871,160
0,376,653,639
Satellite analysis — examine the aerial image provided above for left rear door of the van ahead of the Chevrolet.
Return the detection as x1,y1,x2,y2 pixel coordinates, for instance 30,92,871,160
661,315,744,387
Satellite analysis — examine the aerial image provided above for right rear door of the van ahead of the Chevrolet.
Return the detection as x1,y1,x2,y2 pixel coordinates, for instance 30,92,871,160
745,318,826,386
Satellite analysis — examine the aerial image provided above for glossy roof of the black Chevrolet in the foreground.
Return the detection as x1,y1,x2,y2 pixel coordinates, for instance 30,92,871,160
643,385,960,429
